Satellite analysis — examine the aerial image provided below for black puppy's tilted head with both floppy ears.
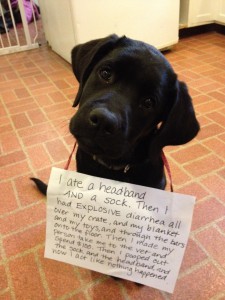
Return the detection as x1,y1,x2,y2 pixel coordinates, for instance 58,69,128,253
70,35,199,164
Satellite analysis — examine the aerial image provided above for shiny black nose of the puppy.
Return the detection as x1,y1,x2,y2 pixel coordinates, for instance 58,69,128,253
89,107,118,135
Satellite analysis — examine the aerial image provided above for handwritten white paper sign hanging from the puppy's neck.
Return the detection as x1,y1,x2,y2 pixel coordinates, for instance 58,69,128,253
45,168,195,293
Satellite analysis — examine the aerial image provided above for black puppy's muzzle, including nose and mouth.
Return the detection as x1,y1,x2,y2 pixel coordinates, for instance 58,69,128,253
69,106,127,159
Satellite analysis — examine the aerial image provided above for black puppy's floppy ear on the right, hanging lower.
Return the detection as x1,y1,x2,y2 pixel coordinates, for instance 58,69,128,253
156,80,200,148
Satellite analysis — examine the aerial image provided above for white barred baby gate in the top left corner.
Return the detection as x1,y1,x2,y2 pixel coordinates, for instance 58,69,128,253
0,0,39,55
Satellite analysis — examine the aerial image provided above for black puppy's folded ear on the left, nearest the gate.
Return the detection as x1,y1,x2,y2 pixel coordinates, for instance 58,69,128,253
71,34,119,107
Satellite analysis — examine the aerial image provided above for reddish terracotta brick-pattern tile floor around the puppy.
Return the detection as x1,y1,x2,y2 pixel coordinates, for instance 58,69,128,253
0,32,225,300
